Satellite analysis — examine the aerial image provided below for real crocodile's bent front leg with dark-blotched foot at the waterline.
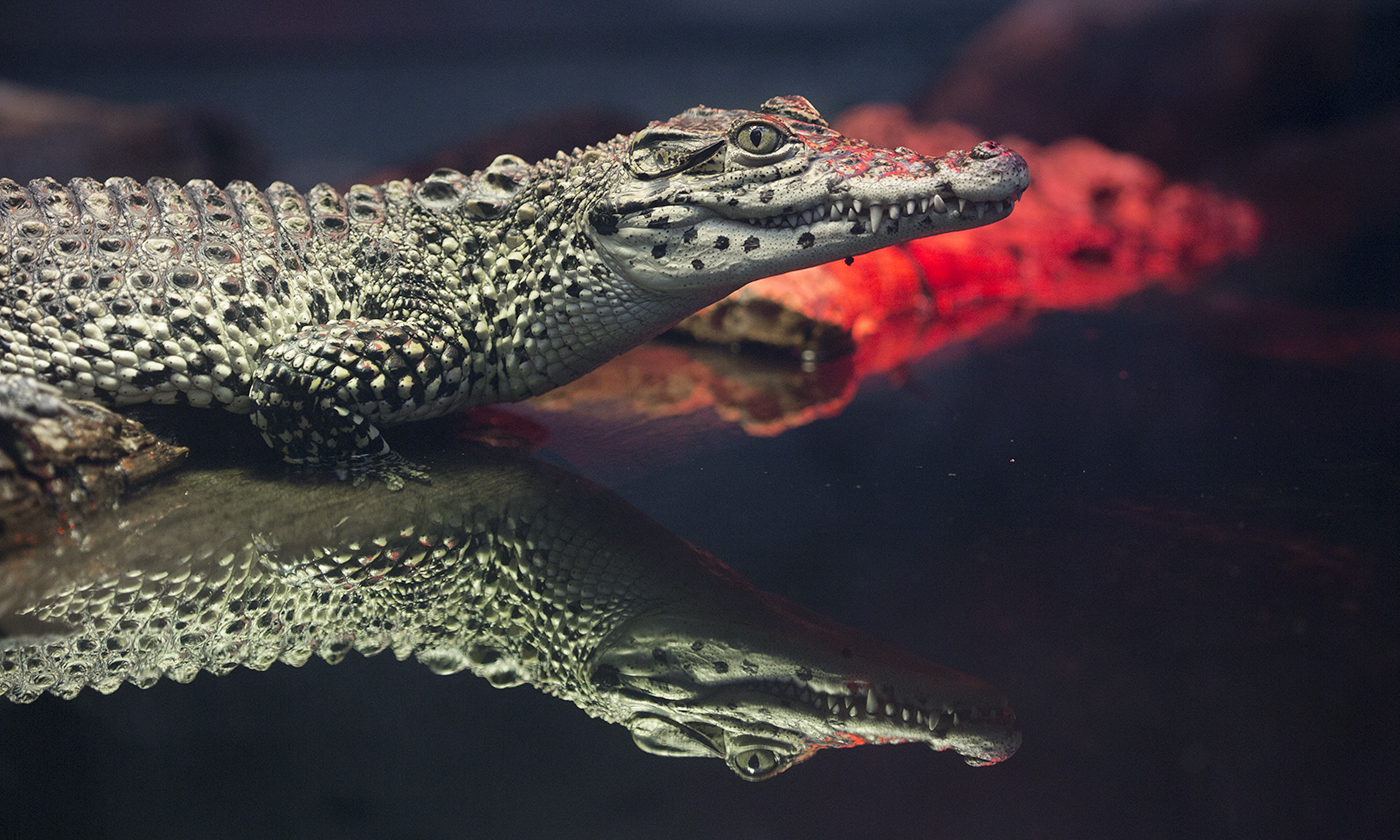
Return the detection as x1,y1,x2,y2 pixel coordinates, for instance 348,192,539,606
251,319,469,489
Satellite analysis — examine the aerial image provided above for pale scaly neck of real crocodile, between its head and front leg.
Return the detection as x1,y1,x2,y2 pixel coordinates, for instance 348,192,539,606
361,151,722,412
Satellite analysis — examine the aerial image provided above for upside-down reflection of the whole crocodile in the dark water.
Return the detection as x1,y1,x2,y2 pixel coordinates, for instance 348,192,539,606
0,451,1021,778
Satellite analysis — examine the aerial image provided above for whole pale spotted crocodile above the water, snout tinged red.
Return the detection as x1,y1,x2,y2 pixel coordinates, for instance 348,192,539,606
0,97,1029,486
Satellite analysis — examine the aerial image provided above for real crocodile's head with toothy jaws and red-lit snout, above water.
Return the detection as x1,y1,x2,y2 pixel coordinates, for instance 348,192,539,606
588,97,1029,297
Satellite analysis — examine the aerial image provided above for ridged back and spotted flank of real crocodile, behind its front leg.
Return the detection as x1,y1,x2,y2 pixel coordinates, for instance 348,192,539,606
0,178,386,412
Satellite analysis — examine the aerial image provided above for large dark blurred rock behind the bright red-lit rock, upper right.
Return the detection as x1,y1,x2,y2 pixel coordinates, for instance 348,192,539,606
913,0,1400,296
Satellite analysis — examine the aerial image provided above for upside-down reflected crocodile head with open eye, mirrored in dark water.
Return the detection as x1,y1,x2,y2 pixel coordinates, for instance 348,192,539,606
591,579,1021,781
